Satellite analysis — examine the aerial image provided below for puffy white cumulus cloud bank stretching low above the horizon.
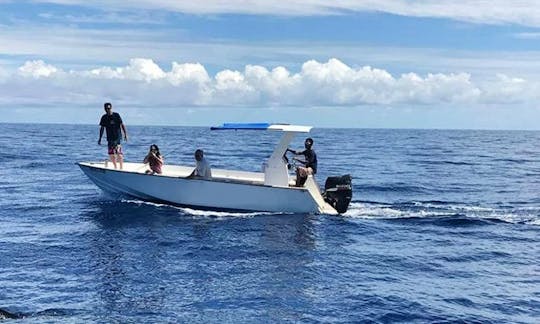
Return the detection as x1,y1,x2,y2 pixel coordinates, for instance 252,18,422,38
0,58,540,107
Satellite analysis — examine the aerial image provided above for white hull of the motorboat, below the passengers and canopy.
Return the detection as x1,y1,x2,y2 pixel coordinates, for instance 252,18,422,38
78,162,335,214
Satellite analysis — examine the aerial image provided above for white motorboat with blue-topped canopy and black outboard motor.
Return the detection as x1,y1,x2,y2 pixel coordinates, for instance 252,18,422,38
78,123,352,214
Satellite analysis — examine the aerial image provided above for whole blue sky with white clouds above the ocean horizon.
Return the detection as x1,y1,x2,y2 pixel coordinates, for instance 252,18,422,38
0,0,540,129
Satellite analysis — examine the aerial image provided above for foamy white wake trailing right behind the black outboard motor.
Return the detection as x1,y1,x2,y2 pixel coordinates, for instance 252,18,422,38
344,201,540,225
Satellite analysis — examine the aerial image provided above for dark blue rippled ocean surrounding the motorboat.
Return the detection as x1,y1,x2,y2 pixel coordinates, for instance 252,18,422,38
0,121,540,323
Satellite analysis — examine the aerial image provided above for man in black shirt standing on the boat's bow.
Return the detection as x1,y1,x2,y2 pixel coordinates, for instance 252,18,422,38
98,102,127,170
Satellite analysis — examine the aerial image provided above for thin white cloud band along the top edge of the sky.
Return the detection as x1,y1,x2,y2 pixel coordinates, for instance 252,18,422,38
28,0,540,26
